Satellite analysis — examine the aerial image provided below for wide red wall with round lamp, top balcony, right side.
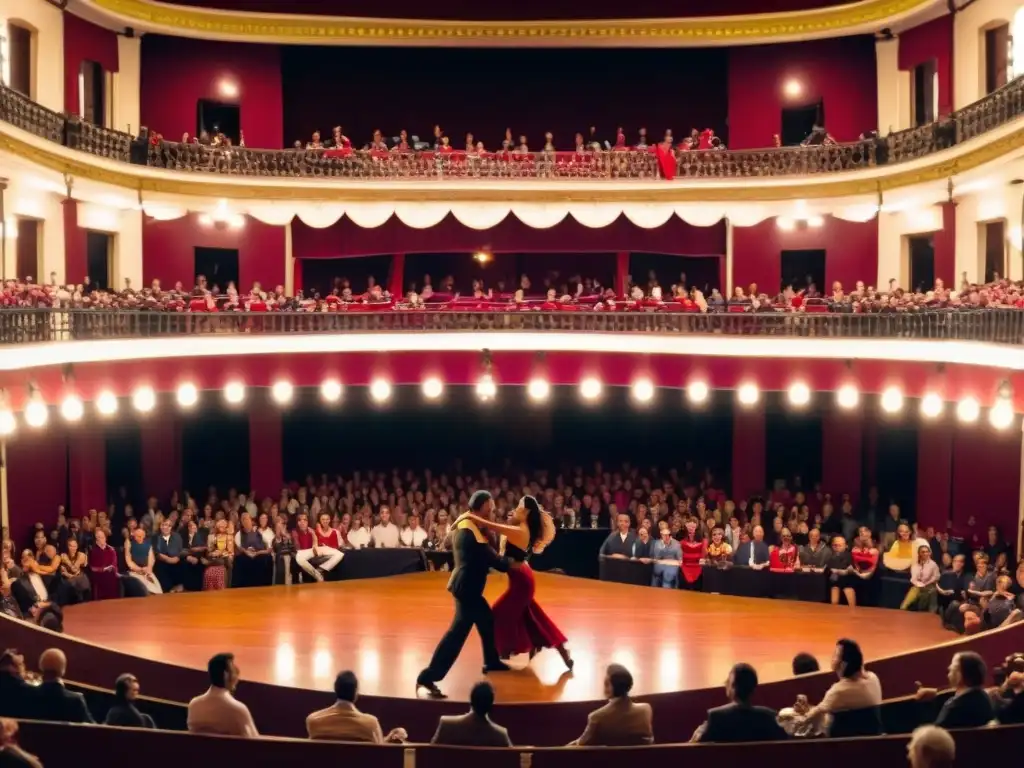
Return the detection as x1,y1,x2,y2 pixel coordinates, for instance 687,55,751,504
728,36,878,150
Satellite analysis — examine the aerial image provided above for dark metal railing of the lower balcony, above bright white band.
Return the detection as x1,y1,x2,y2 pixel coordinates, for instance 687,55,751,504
0,309,1024,344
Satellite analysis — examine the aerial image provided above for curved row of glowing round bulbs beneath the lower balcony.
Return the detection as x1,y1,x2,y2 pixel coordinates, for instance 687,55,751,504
0,374,1014,436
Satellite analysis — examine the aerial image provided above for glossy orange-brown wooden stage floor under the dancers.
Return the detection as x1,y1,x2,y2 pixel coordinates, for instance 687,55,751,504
65,572,954,702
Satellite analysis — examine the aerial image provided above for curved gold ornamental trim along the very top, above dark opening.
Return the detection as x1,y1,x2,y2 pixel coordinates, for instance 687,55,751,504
84,0,935,47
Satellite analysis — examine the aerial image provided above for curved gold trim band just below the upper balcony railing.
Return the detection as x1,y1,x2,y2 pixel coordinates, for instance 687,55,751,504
0,126,1024,203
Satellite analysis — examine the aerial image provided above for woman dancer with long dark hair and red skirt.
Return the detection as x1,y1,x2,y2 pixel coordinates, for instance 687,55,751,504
469,496,573,670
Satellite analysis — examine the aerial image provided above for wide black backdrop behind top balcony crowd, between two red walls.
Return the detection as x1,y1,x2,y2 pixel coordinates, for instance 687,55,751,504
282,46,729,150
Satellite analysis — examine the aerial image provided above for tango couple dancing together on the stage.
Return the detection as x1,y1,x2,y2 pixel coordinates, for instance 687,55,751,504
416,490,572,698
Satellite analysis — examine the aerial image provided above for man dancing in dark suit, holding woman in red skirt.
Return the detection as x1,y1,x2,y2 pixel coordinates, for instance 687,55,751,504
416,490,518,698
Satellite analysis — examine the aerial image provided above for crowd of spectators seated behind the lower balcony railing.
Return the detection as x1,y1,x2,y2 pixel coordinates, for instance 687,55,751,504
0,270,1024,314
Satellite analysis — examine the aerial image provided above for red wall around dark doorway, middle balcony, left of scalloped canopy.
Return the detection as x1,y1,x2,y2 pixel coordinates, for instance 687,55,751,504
142,214,285,291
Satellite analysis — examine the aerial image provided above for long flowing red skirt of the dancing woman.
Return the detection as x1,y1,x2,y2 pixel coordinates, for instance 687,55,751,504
490,563,565,656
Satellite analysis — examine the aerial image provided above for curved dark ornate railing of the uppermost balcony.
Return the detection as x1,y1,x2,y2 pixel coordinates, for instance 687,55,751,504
0,78,1024,180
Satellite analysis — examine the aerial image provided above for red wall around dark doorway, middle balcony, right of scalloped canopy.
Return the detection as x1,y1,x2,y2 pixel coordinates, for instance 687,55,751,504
732,216,879,294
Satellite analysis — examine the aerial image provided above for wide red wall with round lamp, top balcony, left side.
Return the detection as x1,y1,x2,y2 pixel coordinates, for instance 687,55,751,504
140,35,282,148
